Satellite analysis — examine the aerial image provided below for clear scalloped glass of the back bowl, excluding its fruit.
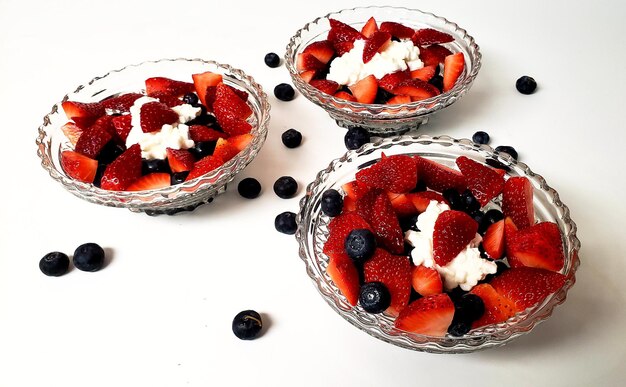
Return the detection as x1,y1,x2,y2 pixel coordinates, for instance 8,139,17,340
285,6,481,137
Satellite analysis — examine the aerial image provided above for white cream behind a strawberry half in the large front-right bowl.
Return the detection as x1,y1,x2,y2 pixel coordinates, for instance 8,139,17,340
404,200,498,291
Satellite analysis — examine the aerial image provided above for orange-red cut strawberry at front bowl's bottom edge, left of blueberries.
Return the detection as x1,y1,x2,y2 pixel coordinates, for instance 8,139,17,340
394,293,454,337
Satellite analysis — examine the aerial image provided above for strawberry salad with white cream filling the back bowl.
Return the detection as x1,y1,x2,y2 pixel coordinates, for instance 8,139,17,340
296,17,465,104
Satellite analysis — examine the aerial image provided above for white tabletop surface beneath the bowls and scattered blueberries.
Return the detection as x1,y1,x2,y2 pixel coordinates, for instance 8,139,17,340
0,0,626,387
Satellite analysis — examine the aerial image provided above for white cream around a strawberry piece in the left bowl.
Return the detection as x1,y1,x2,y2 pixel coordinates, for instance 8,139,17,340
126,97,201,160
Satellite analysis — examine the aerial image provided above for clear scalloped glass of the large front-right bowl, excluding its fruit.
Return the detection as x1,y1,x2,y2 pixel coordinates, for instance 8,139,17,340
296,135,580,353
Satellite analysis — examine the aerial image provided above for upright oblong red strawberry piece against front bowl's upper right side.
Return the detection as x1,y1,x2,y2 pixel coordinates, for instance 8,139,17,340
502,176,535,230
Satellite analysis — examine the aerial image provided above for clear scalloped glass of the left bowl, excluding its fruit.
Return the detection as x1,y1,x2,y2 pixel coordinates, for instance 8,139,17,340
36,58,270,215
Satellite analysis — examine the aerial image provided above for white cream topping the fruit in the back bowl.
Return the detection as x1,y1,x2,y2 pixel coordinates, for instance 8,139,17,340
326,39,424,86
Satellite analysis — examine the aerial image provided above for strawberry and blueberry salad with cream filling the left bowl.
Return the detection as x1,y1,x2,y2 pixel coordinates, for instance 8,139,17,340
60,71,253,191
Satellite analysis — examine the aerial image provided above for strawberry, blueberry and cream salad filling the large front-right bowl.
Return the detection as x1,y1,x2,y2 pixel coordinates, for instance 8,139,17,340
321,154,566,337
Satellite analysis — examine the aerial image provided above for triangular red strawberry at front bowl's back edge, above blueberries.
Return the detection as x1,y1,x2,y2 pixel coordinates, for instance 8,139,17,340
456,156,504,206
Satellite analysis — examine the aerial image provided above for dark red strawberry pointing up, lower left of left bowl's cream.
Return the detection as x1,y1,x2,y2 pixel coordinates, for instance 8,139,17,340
100,144,141,191
